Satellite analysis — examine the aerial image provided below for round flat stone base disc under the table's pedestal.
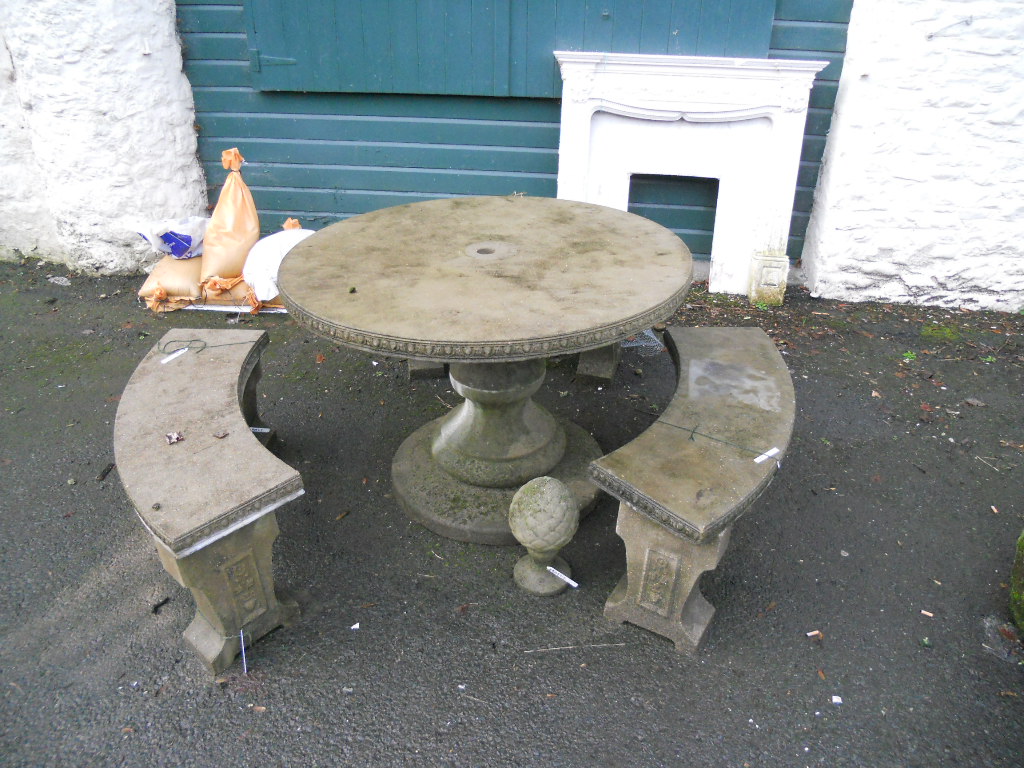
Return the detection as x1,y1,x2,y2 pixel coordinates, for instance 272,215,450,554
391,417,602,546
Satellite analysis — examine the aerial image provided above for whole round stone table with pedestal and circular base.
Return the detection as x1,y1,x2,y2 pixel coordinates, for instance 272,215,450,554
278,196,692,545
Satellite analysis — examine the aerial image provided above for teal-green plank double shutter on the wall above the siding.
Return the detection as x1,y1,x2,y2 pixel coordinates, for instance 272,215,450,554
245,0,775,98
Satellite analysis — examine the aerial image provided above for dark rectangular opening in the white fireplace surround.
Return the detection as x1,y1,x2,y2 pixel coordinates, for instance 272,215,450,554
628,173,719,262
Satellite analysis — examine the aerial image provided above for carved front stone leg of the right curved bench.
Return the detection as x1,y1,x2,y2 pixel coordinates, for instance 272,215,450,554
604,502,730,653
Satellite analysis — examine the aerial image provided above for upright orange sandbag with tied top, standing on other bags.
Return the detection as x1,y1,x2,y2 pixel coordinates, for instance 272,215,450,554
201,148,259,282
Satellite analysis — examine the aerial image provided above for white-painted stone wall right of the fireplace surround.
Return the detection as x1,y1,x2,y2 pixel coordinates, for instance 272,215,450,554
803,0,1024,311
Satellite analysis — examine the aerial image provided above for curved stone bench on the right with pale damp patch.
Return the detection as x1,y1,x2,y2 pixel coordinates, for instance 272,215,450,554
590,328,796,652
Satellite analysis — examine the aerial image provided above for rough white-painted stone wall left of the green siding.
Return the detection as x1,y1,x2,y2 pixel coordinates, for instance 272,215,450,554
0,0,207,272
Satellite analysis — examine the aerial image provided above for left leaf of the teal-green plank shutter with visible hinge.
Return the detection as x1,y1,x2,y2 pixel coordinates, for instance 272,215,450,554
245,0,510,96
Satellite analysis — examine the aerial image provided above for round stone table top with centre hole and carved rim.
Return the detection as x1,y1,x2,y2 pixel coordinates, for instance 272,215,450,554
279,196,692,361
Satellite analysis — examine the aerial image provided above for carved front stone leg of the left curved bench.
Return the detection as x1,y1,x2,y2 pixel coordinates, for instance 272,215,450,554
151,512,299,674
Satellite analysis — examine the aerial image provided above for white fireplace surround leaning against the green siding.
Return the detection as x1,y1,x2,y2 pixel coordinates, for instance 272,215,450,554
554,51,827,303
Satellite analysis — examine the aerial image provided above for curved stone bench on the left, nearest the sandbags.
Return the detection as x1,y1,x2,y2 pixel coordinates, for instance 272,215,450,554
114,329,303,674
